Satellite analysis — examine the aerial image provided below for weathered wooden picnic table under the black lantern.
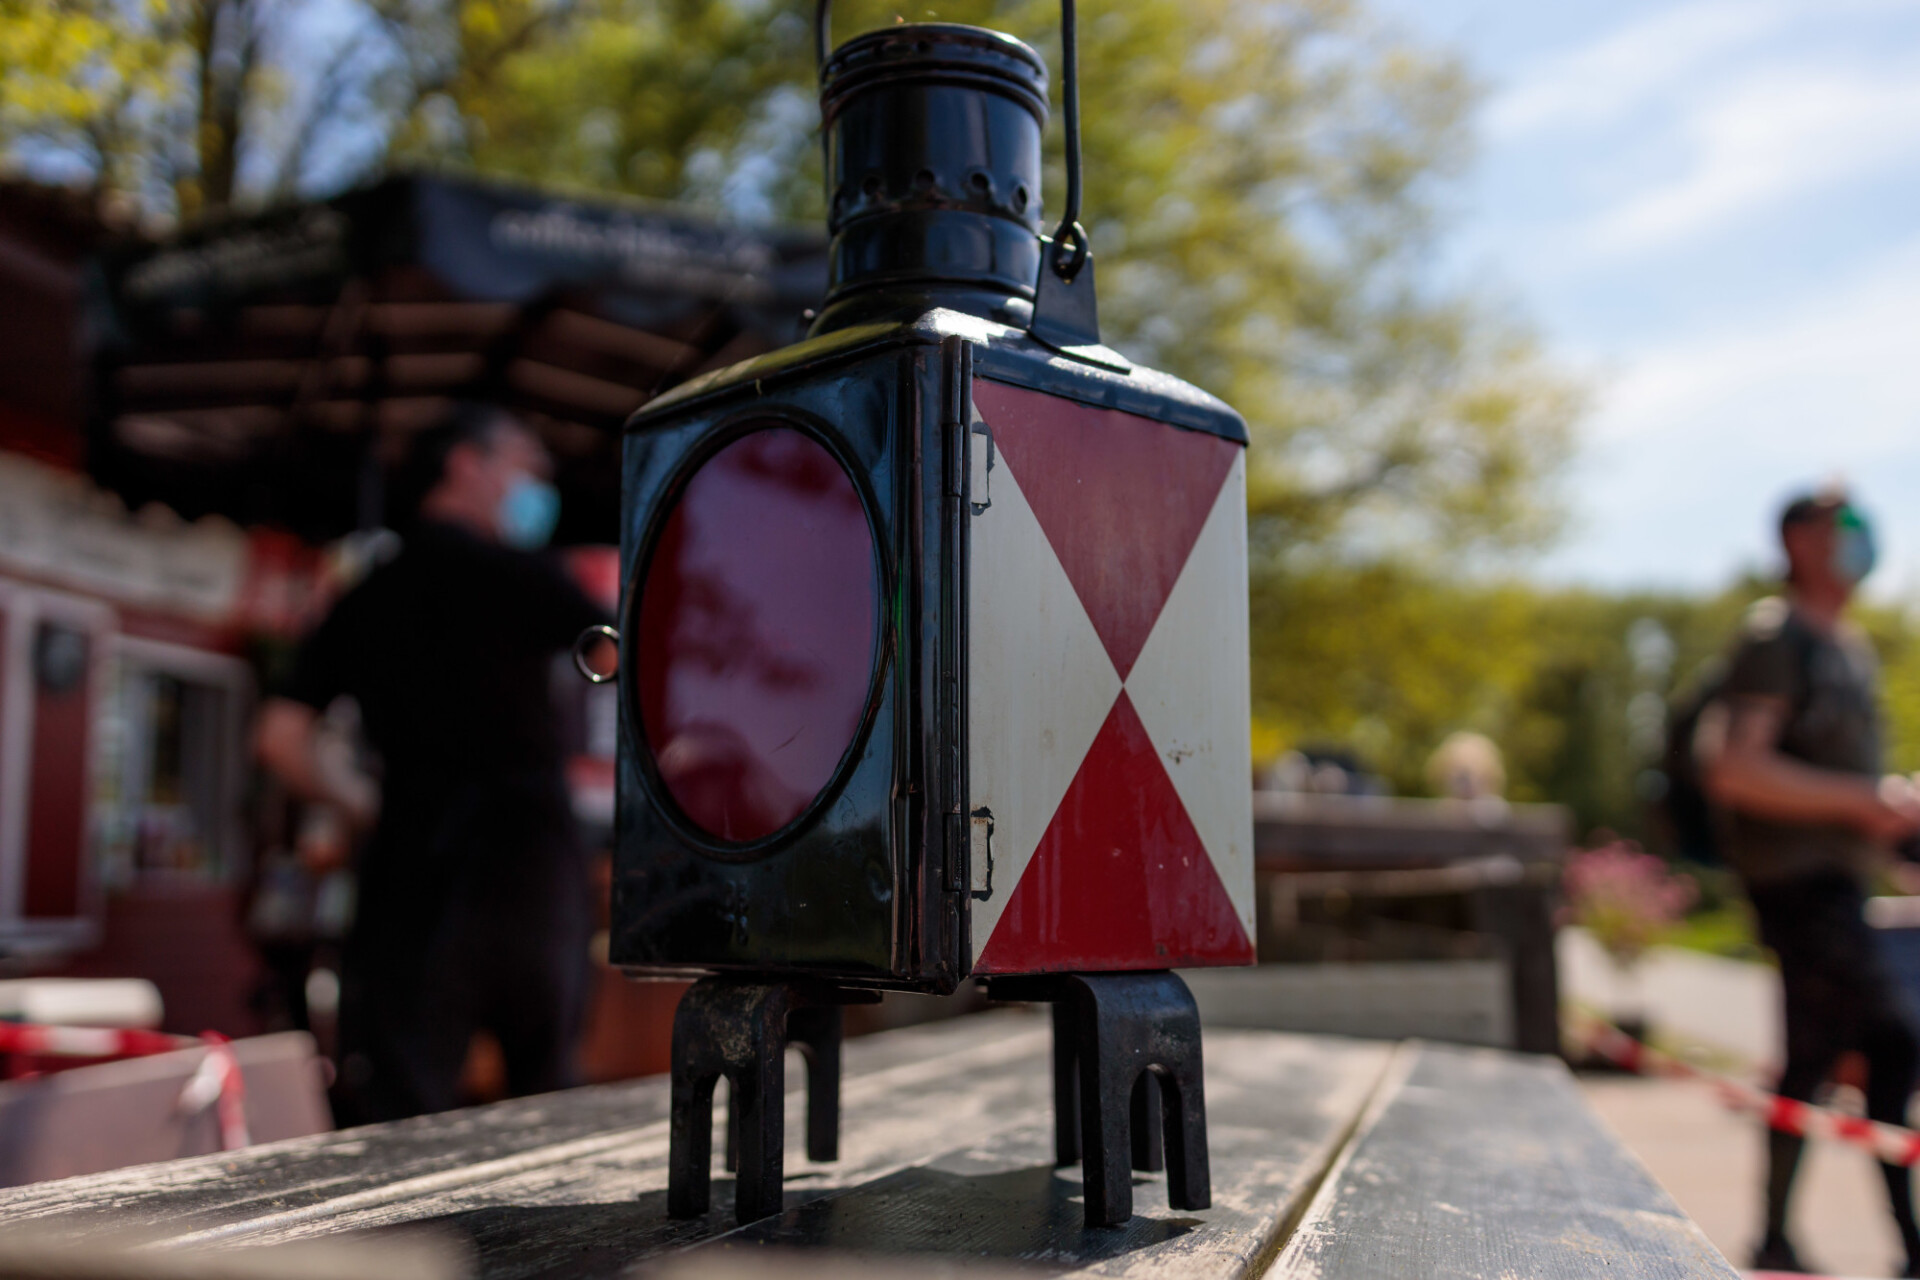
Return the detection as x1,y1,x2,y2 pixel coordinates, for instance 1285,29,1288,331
0,1009,1736,1280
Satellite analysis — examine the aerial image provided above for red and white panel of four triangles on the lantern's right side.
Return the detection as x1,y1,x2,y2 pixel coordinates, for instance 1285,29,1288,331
968,380,1254,973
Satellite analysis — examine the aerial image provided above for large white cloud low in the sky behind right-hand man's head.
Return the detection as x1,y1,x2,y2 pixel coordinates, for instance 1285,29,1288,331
1542,236,1920,595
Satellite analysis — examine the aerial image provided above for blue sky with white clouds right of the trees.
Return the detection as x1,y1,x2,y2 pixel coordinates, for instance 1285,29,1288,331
1373,0,1920,599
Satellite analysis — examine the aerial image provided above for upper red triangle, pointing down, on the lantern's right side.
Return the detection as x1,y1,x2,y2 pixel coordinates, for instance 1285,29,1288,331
973,380,1240,679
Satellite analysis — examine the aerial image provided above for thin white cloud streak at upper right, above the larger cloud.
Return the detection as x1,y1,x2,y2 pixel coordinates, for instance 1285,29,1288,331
1580,59,1920,257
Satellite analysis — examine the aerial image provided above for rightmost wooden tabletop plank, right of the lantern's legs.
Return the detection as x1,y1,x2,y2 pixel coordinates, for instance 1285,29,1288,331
1271,1046,1738,1280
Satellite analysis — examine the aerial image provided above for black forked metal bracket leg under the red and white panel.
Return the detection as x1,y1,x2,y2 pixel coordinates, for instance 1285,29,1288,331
989,973,1213,1226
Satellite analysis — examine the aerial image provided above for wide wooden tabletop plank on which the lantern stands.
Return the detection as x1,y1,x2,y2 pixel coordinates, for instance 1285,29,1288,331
161,1019,1388,1276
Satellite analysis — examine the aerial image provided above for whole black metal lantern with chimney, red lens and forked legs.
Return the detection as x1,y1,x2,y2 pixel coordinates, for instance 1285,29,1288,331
611,6,1254,1222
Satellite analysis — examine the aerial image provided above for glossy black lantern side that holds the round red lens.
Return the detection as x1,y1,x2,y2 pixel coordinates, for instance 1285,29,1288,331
612,336,925,990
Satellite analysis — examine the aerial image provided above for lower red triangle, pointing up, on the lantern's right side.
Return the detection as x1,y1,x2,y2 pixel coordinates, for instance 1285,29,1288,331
973,693,1254,973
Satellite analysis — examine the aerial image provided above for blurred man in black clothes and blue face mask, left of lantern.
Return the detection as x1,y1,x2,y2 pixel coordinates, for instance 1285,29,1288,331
255,405,607,1123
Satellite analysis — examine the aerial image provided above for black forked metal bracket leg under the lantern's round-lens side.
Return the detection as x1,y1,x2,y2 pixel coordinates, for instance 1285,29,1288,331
666,977,879,1222
